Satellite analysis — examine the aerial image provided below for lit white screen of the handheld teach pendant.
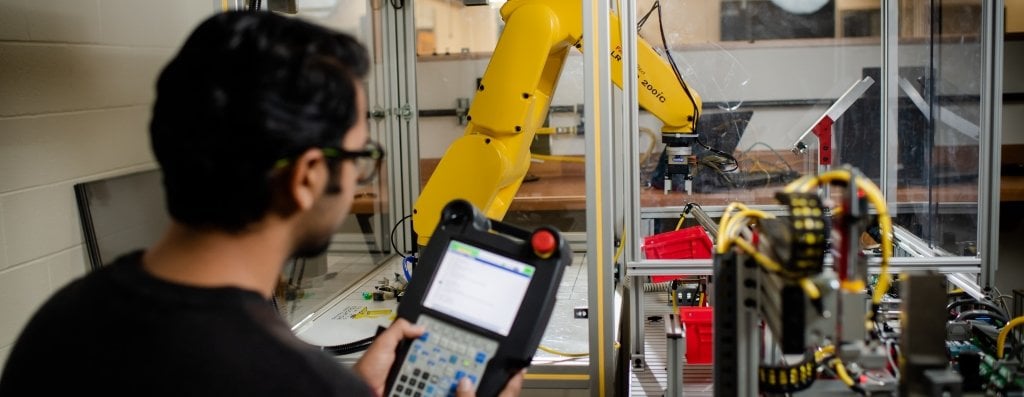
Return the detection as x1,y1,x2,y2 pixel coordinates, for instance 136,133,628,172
423,240,536,336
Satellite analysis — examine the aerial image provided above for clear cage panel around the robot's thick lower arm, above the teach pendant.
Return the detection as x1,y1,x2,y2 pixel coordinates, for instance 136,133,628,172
416,0,586,231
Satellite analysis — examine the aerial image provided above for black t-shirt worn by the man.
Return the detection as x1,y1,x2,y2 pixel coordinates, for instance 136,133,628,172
0,253,372,396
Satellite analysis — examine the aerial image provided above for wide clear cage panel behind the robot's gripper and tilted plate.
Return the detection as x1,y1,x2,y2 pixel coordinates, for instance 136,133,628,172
638,0,882,238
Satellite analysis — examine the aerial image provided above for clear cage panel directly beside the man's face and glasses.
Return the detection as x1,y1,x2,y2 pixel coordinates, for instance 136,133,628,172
276,0,392,324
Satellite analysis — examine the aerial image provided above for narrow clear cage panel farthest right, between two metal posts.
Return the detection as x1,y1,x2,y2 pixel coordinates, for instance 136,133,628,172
890,0,983,256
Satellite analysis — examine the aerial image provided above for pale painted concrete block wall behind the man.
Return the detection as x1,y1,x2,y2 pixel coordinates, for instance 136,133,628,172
0,0,220,367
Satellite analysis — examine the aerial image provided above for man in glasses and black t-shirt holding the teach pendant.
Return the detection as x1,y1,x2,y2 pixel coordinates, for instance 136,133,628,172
0,12,522,396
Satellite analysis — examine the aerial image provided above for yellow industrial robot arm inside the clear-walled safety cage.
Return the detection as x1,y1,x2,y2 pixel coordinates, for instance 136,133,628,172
413,0,700,246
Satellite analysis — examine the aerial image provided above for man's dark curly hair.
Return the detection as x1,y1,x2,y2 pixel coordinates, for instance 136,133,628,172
150,11,370,232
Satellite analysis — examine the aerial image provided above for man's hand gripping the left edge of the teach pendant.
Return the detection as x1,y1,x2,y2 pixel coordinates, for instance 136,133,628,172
353,318,425,396
